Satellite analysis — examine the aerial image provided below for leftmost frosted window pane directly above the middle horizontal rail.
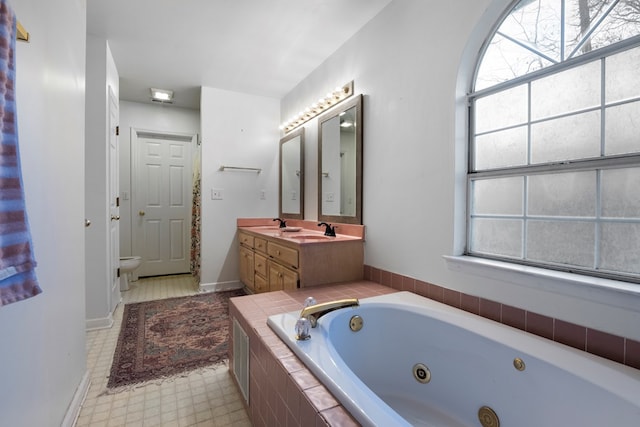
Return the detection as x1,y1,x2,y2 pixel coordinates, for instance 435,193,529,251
474,126,527,170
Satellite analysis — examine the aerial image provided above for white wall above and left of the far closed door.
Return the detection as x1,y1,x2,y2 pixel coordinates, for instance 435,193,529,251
118,101,200,256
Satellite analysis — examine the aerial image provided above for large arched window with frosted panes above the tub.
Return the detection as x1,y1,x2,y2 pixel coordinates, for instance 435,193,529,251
467,0,640,282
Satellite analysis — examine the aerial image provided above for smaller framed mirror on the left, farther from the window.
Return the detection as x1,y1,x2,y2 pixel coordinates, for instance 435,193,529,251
279,127,304,219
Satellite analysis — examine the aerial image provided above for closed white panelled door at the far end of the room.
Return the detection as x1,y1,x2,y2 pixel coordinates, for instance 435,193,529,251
132,129,195,276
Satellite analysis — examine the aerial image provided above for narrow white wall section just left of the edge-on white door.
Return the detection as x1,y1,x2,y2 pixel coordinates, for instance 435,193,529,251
85,35,120,329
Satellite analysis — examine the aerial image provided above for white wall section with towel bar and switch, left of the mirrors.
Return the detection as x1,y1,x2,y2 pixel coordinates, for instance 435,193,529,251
200,87,280,286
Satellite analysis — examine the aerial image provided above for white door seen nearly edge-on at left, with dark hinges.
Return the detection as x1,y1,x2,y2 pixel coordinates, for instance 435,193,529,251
108,87,120,313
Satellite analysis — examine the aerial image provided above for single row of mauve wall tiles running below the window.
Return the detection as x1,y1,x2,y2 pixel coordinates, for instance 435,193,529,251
364,265,640,369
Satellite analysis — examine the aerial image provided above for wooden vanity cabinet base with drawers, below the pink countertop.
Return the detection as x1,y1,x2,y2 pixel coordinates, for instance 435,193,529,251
238,227,364,293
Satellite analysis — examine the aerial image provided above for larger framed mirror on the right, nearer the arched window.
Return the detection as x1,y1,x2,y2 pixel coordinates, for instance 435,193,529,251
318,95,362,224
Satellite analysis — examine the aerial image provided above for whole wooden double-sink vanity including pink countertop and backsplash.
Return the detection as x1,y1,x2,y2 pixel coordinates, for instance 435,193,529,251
237,218,364,293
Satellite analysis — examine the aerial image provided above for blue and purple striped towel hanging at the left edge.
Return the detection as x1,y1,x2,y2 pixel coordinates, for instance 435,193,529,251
0,0,42,306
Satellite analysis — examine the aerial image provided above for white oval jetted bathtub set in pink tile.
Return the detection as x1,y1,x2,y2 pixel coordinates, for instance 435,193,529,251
268,292,640,427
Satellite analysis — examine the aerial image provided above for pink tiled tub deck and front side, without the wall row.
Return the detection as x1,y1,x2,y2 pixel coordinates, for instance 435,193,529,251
229,281,396,427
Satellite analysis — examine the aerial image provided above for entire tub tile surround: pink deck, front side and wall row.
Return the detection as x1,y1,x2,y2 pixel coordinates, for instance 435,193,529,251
229,274,640,427
